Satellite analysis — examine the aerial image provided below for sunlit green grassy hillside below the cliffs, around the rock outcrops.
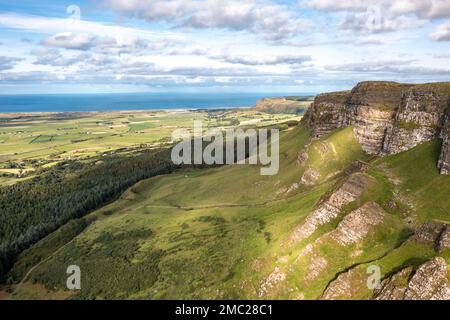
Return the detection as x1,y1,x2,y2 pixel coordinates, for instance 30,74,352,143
4,128,450,299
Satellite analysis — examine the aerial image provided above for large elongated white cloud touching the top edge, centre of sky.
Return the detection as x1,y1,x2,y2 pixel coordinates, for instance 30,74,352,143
105,0,311,41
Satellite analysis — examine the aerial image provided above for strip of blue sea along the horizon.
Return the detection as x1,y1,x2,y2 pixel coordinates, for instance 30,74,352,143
0,93,306,113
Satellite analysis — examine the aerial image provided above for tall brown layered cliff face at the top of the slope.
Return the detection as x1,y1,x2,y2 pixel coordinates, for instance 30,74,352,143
304,82,450,174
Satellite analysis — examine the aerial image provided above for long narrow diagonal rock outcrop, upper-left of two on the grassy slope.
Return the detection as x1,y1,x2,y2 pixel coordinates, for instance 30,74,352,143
291,174,369,242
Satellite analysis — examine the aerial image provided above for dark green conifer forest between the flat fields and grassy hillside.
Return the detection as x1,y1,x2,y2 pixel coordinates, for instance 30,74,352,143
0,150,177,280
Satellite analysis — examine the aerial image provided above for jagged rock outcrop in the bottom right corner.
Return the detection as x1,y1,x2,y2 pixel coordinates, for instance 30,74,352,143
375,257,450,300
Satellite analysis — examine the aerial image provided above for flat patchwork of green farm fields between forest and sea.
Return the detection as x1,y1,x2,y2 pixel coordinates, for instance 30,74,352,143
0,109,300,185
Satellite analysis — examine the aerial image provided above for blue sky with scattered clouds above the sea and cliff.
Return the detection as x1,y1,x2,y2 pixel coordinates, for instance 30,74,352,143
0,0,450,94
